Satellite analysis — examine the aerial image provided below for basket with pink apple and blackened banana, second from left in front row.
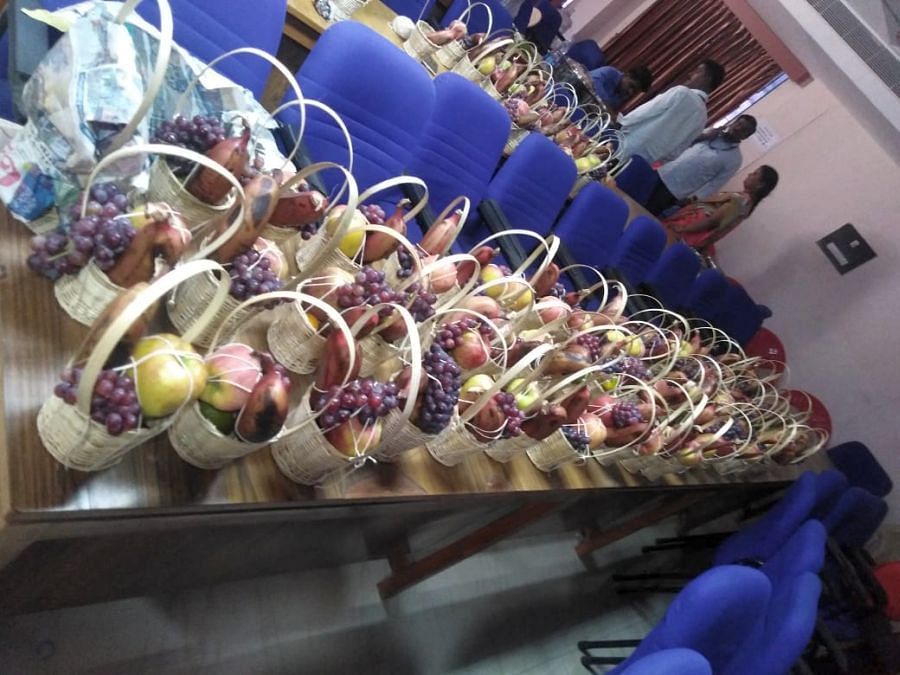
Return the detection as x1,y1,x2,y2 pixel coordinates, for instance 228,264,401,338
169,291,350,469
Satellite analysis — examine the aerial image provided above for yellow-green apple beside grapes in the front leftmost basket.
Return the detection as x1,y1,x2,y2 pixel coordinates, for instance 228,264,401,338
131,333,207,417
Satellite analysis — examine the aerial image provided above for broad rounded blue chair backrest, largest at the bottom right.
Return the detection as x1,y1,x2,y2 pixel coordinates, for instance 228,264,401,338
623,565,772,673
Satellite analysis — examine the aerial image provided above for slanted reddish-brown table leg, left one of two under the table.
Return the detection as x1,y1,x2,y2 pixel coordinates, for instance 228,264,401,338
378,502,563,600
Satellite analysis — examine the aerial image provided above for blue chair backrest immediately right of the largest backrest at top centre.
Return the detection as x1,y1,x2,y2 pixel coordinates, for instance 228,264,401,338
406,73,509,241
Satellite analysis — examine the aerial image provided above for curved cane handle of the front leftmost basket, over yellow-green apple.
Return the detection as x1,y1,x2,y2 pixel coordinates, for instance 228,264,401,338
70,260,231,416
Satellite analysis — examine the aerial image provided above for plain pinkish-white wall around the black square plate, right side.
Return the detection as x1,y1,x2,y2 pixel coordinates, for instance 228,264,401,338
717,81,900,525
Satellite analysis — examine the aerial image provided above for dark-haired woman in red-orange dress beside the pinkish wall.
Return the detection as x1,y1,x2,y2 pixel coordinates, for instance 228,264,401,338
662,164,778,253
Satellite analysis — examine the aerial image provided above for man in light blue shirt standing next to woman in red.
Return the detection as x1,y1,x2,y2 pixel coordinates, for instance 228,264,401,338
647,115,756,216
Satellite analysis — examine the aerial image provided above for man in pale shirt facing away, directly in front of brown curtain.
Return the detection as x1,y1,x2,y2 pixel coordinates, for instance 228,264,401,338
620,59,725,164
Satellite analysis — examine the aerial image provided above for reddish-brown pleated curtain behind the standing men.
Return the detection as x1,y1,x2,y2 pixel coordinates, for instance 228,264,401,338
603,0,781,122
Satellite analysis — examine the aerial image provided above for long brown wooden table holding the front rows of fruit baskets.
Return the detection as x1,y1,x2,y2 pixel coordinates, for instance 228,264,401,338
0,199,816,609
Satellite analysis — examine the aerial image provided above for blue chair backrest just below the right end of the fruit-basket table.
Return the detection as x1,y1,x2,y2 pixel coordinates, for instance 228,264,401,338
713,471,816,565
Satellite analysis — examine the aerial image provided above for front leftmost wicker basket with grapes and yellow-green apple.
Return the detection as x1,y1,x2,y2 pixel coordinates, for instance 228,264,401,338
37,260,228,471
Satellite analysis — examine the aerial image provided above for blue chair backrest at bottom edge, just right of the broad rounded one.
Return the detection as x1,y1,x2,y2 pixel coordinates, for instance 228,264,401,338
717,572,822,675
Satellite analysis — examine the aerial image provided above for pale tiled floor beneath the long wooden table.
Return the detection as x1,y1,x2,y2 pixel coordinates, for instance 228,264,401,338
0,531,670,675
